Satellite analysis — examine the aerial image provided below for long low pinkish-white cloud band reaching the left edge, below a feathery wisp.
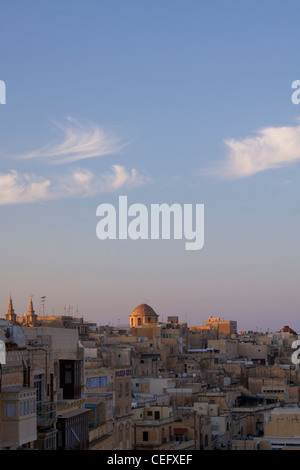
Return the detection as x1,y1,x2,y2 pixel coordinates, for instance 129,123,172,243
0,165,150,205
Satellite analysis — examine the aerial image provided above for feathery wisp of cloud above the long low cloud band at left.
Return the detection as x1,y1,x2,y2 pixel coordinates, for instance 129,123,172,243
17,117,127,164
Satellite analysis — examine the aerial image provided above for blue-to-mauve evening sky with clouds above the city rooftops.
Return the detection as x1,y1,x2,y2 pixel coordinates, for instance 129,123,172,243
0,0,300,332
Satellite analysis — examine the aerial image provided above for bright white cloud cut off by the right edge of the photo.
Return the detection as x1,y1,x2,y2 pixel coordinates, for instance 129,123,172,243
206,120,300,179
